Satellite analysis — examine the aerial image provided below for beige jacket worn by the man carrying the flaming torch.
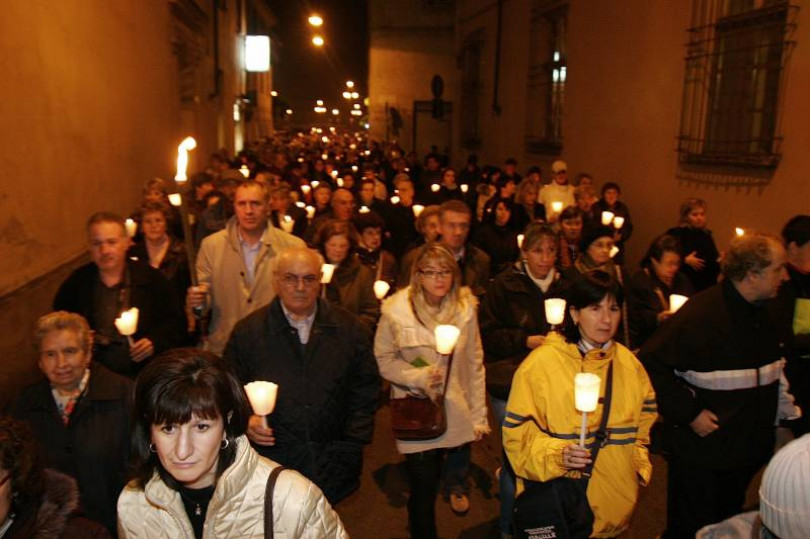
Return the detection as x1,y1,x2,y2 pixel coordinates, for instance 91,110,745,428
197,217,306,355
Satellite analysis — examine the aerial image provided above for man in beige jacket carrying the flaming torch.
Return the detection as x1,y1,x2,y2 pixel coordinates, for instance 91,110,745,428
187,180,304,355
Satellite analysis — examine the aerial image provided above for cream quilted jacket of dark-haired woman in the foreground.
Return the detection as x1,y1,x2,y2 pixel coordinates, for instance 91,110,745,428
118,436,349,539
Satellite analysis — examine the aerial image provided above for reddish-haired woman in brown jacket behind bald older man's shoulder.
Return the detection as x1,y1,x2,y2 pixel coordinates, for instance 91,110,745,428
315,219,380,330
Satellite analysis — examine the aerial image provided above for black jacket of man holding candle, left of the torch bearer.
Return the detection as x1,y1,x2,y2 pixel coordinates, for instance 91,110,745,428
53,261,186,378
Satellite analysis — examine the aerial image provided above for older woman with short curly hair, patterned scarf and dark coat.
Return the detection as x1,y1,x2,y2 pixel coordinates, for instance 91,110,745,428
11,311,132,531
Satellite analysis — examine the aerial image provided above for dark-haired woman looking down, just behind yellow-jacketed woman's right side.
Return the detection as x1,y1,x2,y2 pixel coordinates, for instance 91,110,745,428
627,234,693,349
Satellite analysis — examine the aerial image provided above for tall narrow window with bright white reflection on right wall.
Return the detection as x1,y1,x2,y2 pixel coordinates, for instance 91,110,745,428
526,0,568,155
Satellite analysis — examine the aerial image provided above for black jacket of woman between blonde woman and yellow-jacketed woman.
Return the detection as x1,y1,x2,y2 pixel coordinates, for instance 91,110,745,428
478,262,566,400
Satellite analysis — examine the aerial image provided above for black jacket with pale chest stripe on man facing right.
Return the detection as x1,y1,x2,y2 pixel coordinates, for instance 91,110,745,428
639,281,785,470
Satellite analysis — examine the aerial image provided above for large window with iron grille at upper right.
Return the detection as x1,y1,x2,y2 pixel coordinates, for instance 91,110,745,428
678,0,798,169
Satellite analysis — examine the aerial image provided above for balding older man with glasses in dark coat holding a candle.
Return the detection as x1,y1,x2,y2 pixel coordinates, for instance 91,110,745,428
224,248,380,504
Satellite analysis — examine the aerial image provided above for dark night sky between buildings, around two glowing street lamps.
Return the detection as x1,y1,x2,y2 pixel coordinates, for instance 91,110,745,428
270,0,369,124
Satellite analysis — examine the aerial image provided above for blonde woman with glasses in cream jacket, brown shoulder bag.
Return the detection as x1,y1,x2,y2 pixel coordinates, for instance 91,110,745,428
374,243,489,539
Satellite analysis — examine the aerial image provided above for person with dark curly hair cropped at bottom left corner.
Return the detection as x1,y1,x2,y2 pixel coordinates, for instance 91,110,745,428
0,418,110,539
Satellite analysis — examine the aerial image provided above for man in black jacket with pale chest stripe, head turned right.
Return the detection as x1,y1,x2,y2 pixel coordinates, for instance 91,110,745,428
640,233,797,537
